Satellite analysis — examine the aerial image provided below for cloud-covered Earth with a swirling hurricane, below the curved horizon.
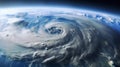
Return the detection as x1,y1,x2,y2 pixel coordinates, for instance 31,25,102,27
0,7,120,67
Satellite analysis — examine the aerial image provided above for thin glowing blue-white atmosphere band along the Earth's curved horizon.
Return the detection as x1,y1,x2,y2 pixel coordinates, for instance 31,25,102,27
0,3,119,17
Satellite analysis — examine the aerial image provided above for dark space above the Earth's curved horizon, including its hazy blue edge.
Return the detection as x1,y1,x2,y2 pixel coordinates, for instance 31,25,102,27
0,0,120,15
